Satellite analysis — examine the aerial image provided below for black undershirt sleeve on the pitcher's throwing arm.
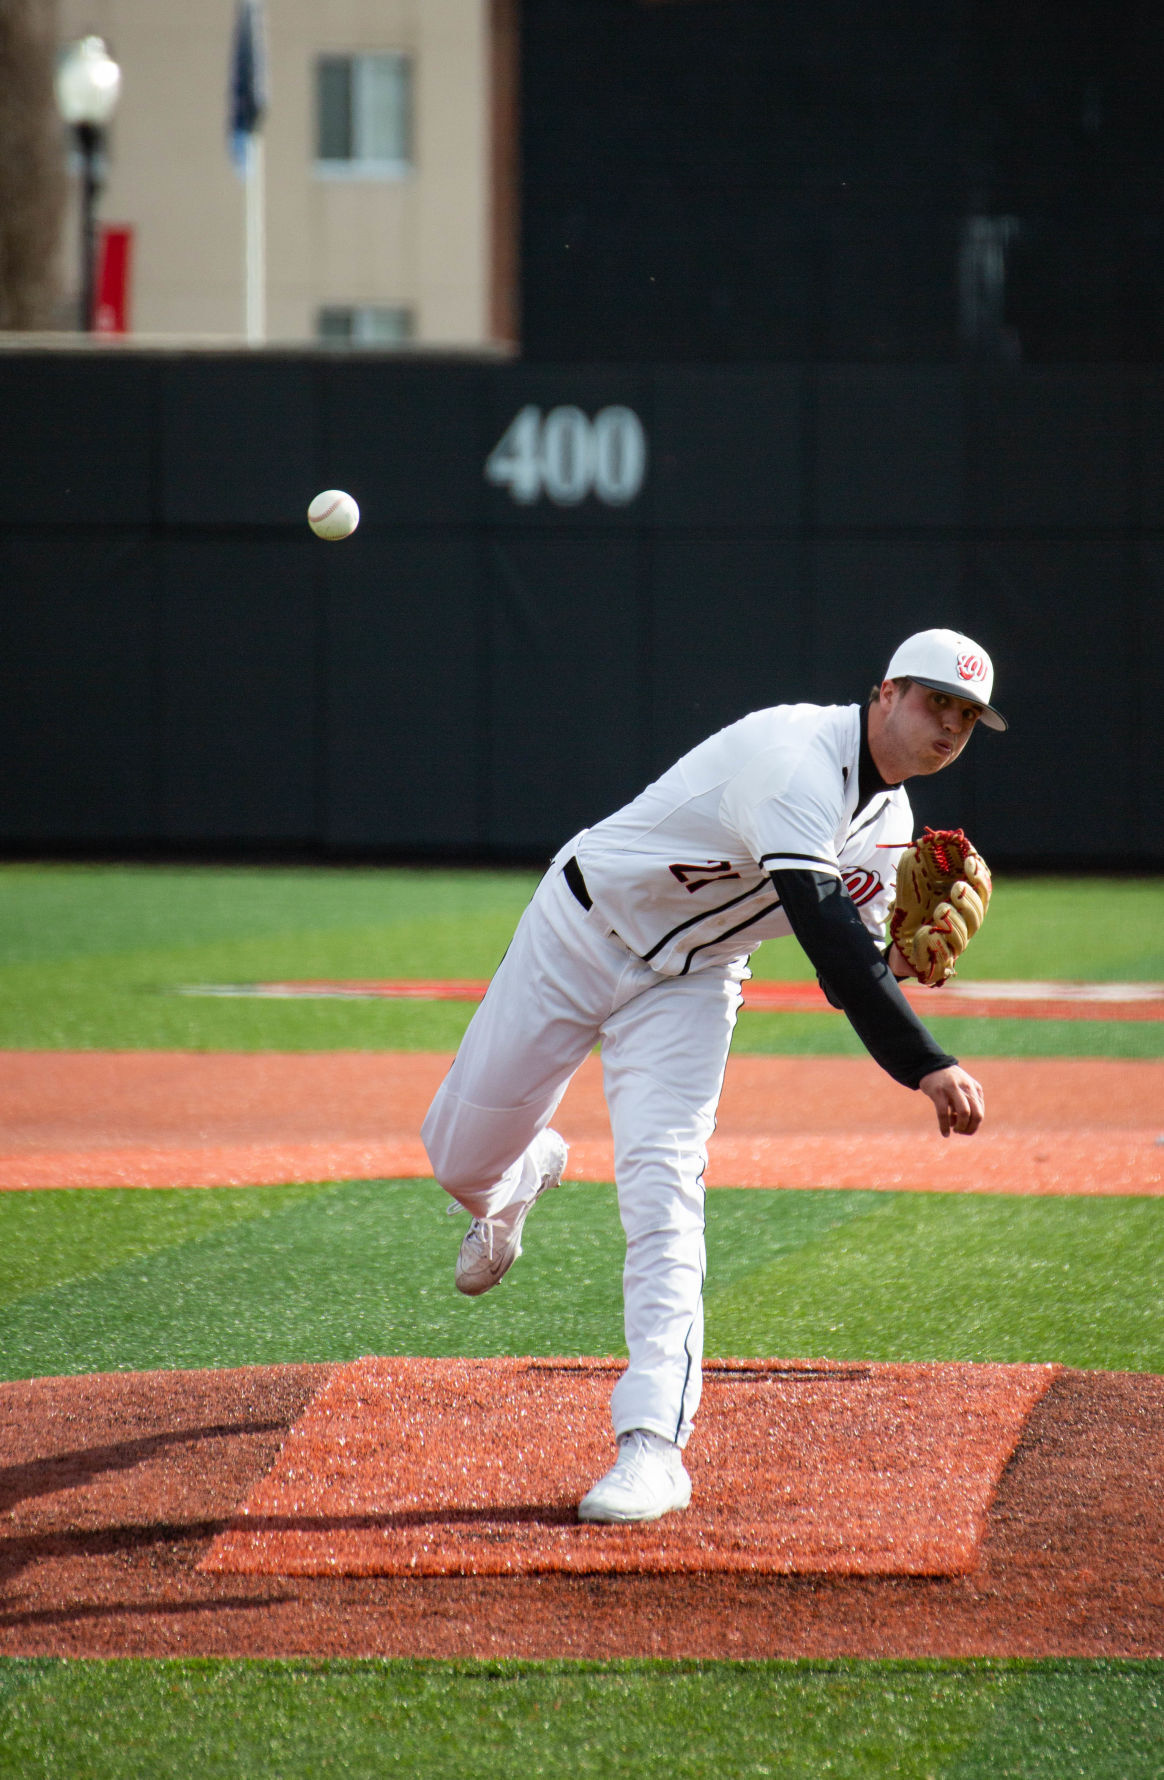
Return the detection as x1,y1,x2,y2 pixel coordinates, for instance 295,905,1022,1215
769,870,958,1088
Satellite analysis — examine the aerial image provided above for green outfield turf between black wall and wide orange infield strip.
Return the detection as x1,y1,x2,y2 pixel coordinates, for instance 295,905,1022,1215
0,865,1164,1057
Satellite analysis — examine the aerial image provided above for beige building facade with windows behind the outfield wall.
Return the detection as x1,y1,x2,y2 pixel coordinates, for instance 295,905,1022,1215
57,0,513,349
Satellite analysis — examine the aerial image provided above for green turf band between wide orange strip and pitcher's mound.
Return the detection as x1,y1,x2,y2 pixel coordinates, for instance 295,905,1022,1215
0,1180,1164,1378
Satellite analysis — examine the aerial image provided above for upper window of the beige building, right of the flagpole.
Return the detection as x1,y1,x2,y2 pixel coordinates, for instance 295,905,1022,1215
315,53,413,180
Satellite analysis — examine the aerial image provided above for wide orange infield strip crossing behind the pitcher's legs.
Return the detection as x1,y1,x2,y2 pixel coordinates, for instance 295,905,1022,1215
0,1052,1164,1194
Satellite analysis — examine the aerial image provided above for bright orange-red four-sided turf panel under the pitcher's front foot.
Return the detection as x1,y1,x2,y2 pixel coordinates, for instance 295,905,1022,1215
199,1358,1057,1575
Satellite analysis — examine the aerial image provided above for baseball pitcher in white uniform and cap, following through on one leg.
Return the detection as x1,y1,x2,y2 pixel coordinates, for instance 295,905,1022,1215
422,630,1006,1522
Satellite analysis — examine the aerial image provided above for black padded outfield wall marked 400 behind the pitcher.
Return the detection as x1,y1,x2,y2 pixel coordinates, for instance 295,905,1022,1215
0,349,1164,865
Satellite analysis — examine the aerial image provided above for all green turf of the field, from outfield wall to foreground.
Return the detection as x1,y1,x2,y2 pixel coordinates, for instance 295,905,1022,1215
0,865,1164,1780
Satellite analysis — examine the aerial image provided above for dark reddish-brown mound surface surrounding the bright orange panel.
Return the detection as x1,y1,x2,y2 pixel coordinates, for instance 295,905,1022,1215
0,1367,1164,1657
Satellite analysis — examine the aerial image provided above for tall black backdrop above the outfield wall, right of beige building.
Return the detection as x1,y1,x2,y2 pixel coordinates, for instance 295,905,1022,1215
520,0,1164,365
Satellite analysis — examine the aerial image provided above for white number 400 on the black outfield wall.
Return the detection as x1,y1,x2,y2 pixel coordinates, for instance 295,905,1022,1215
486,404,646,507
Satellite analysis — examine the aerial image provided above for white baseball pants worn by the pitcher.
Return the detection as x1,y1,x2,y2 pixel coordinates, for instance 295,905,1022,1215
422,847,748,1445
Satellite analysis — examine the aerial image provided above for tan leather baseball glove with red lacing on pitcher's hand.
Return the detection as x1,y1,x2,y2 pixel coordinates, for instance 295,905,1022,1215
890,828,991,988
